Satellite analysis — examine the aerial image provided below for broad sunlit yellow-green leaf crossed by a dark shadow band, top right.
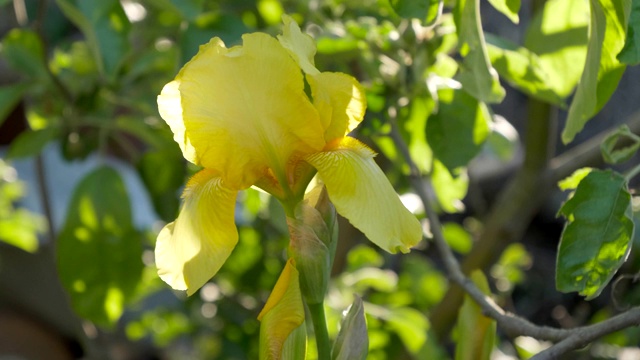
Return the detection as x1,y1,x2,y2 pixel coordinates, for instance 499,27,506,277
524,0,589,98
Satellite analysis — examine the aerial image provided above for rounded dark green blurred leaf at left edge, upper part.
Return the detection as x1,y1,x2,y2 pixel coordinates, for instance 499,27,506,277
0,28,48,79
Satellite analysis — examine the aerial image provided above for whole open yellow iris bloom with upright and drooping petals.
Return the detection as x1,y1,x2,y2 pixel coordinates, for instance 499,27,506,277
155,17,422,295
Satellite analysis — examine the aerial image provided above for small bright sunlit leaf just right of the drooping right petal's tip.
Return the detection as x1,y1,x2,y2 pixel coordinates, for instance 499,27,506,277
431,160,469,213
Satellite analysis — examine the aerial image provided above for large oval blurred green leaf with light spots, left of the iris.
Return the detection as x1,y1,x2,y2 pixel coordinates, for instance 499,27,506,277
57,166,144,326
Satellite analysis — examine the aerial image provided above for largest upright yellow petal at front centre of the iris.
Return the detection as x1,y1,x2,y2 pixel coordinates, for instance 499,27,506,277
176,33,325,189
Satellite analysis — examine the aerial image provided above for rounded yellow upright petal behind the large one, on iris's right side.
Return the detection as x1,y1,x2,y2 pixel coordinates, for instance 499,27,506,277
307,72,367,142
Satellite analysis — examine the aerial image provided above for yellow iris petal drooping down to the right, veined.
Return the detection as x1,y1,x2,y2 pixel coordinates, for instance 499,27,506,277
305,137,422,253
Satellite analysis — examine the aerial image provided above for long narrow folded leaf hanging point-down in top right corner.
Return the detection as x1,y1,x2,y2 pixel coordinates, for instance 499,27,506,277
562,0,631,144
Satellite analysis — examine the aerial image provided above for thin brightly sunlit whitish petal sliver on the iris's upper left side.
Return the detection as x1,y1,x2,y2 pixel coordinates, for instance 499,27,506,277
158,80,198,165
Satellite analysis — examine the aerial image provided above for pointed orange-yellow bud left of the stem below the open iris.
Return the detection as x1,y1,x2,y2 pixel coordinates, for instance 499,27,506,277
258,259,304,360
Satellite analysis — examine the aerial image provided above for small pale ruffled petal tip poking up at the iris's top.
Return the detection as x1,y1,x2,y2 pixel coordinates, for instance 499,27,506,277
278,15,320,75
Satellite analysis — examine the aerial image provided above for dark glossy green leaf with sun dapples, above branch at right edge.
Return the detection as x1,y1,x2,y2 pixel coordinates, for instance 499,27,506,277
556,170,634,300
